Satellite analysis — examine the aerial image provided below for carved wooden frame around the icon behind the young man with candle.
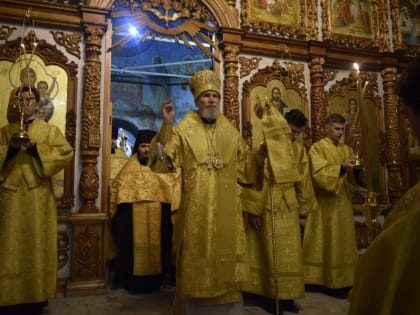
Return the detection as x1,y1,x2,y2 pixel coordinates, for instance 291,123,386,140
326,72,387,203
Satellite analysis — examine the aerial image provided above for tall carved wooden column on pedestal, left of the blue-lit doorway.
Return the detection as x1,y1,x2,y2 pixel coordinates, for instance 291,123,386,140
65,6,108,296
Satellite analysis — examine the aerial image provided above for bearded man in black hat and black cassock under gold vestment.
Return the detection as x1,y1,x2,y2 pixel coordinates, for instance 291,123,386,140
110,130,180,293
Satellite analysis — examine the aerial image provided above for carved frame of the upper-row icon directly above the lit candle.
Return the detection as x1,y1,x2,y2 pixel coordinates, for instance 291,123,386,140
321,0,390,51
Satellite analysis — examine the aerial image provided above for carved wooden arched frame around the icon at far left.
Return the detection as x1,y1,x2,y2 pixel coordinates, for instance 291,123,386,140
0,25,77,209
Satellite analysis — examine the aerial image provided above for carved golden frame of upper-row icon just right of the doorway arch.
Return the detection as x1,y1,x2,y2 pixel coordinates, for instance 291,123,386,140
241,0,317,40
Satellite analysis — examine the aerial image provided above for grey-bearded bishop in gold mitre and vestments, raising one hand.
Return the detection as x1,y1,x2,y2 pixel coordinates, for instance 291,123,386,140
151,70,264,315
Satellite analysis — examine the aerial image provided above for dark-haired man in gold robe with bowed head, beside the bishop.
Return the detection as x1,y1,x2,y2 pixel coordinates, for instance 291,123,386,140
241,109,317,313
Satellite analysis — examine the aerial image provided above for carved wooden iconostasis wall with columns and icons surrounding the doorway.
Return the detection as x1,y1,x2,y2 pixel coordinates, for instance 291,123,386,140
0,0,420,296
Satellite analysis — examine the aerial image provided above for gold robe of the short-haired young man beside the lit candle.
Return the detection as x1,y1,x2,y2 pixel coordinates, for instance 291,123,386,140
303,138,358,288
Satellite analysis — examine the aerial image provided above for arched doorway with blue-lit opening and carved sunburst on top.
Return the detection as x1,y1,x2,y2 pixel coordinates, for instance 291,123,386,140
102,1,237,292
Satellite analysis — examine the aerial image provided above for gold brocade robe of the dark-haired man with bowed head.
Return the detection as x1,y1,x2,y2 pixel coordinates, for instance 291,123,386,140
241,143,317,299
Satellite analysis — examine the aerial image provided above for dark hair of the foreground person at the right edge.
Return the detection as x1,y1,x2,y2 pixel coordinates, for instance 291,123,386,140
397,58,420,114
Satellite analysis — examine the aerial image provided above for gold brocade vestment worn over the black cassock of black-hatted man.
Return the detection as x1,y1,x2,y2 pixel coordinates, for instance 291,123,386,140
110,155,181,275
